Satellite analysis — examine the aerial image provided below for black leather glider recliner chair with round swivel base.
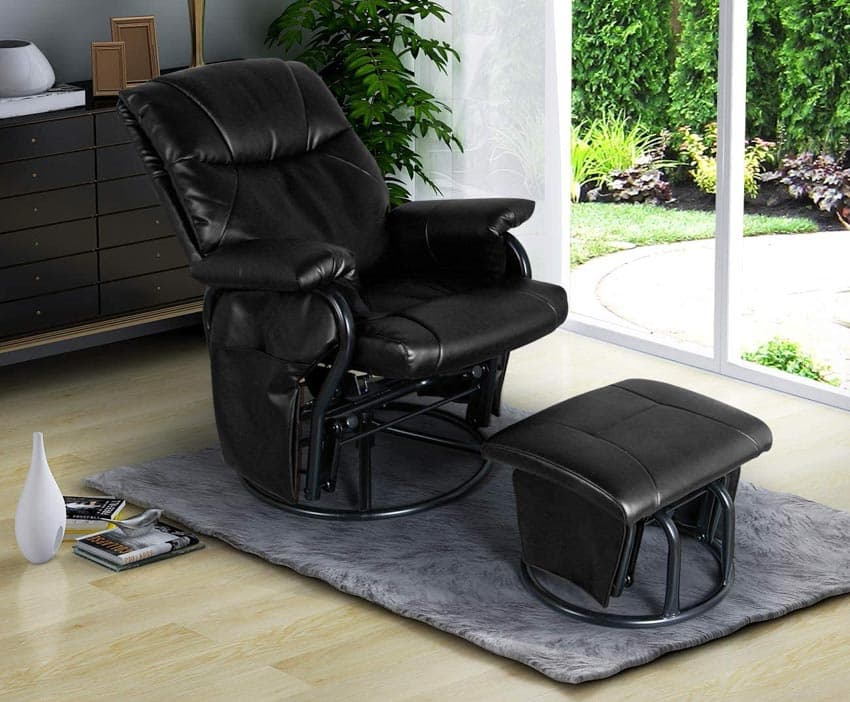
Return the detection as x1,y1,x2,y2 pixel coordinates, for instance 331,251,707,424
119,59,567,519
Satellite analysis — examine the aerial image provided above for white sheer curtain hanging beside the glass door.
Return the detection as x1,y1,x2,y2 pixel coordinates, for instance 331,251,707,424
414,0,571,282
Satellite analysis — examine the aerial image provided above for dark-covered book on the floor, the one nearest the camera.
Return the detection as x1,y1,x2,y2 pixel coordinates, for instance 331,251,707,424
74,522,203,570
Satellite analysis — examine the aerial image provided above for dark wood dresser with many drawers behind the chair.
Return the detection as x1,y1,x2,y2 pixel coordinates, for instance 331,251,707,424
0,105,203,353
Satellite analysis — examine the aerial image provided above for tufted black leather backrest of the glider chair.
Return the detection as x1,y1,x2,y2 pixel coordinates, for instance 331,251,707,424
119,59,388,272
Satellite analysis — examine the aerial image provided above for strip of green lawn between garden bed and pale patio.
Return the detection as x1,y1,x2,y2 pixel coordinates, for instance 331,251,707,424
570,202,818,267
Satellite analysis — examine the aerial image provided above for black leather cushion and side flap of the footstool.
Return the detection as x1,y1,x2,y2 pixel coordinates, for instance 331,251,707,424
482,379,773,605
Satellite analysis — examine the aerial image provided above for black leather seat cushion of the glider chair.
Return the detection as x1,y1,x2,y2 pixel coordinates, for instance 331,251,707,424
354,278,567,379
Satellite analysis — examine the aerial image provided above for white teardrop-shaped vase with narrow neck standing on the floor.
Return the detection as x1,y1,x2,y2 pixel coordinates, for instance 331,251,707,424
15,431,65,563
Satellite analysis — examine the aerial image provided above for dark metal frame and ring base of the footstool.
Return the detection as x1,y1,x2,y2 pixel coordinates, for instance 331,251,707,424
520,476,735,629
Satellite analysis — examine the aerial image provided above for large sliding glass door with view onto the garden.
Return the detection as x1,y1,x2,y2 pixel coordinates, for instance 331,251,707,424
564,0,850,408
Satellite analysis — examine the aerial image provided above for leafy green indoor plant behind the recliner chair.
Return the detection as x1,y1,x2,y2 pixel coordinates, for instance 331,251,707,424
266,0,461,204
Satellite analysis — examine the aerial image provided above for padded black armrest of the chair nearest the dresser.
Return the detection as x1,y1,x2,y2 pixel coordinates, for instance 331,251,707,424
190,239,356,292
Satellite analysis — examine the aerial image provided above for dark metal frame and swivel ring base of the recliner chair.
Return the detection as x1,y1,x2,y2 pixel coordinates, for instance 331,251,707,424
238,232,531,520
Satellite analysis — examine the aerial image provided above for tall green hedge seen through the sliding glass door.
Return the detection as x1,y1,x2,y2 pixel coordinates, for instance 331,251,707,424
573,0,850,154
